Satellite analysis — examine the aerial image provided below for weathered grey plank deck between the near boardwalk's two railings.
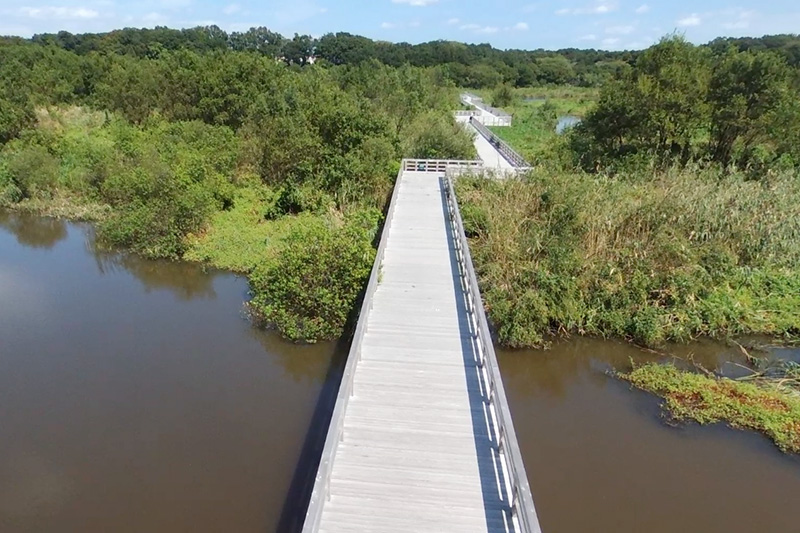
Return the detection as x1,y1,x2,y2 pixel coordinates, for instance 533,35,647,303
320,172,511,533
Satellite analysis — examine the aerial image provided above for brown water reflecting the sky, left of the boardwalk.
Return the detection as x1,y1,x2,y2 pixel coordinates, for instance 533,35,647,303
0,211,334,533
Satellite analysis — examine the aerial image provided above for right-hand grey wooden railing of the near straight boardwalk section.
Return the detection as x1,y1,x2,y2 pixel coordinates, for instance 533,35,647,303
443,176,542,533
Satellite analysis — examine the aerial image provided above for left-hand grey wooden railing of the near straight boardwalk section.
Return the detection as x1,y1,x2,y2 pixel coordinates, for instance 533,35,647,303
303,160,405,533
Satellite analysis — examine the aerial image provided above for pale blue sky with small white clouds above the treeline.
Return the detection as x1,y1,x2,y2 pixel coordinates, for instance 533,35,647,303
0,0,800,50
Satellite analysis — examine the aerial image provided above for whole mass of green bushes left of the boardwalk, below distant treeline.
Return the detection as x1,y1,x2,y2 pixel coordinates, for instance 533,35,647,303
0,39,473,340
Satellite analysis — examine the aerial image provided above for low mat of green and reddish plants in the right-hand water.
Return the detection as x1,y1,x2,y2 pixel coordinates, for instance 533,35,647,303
620,363,800,453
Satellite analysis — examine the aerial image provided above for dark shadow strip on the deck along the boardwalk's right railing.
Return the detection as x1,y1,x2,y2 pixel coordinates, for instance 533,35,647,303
440,178,515,533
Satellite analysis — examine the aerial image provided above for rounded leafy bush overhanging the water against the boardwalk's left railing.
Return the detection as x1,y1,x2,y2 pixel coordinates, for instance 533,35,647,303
250,210,380,342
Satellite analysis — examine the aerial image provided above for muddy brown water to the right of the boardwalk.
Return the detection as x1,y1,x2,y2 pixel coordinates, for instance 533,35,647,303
500,339,800,533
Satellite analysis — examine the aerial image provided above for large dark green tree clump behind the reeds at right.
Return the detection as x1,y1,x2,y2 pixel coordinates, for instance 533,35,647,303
571,36,800,172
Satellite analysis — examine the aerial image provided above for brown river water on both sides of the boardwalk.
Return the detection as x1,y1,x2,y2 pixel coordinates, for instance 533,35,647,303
0,211,800,533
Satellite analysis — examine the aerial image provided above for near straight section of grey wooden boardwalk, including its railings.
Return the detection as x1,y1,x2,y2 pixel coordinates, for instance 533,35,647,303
303,160,541,533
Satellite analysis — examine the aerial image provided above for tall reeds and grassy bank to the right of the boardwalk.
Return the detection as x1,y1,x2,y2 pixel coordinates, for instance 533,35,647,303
457,169,800,347
